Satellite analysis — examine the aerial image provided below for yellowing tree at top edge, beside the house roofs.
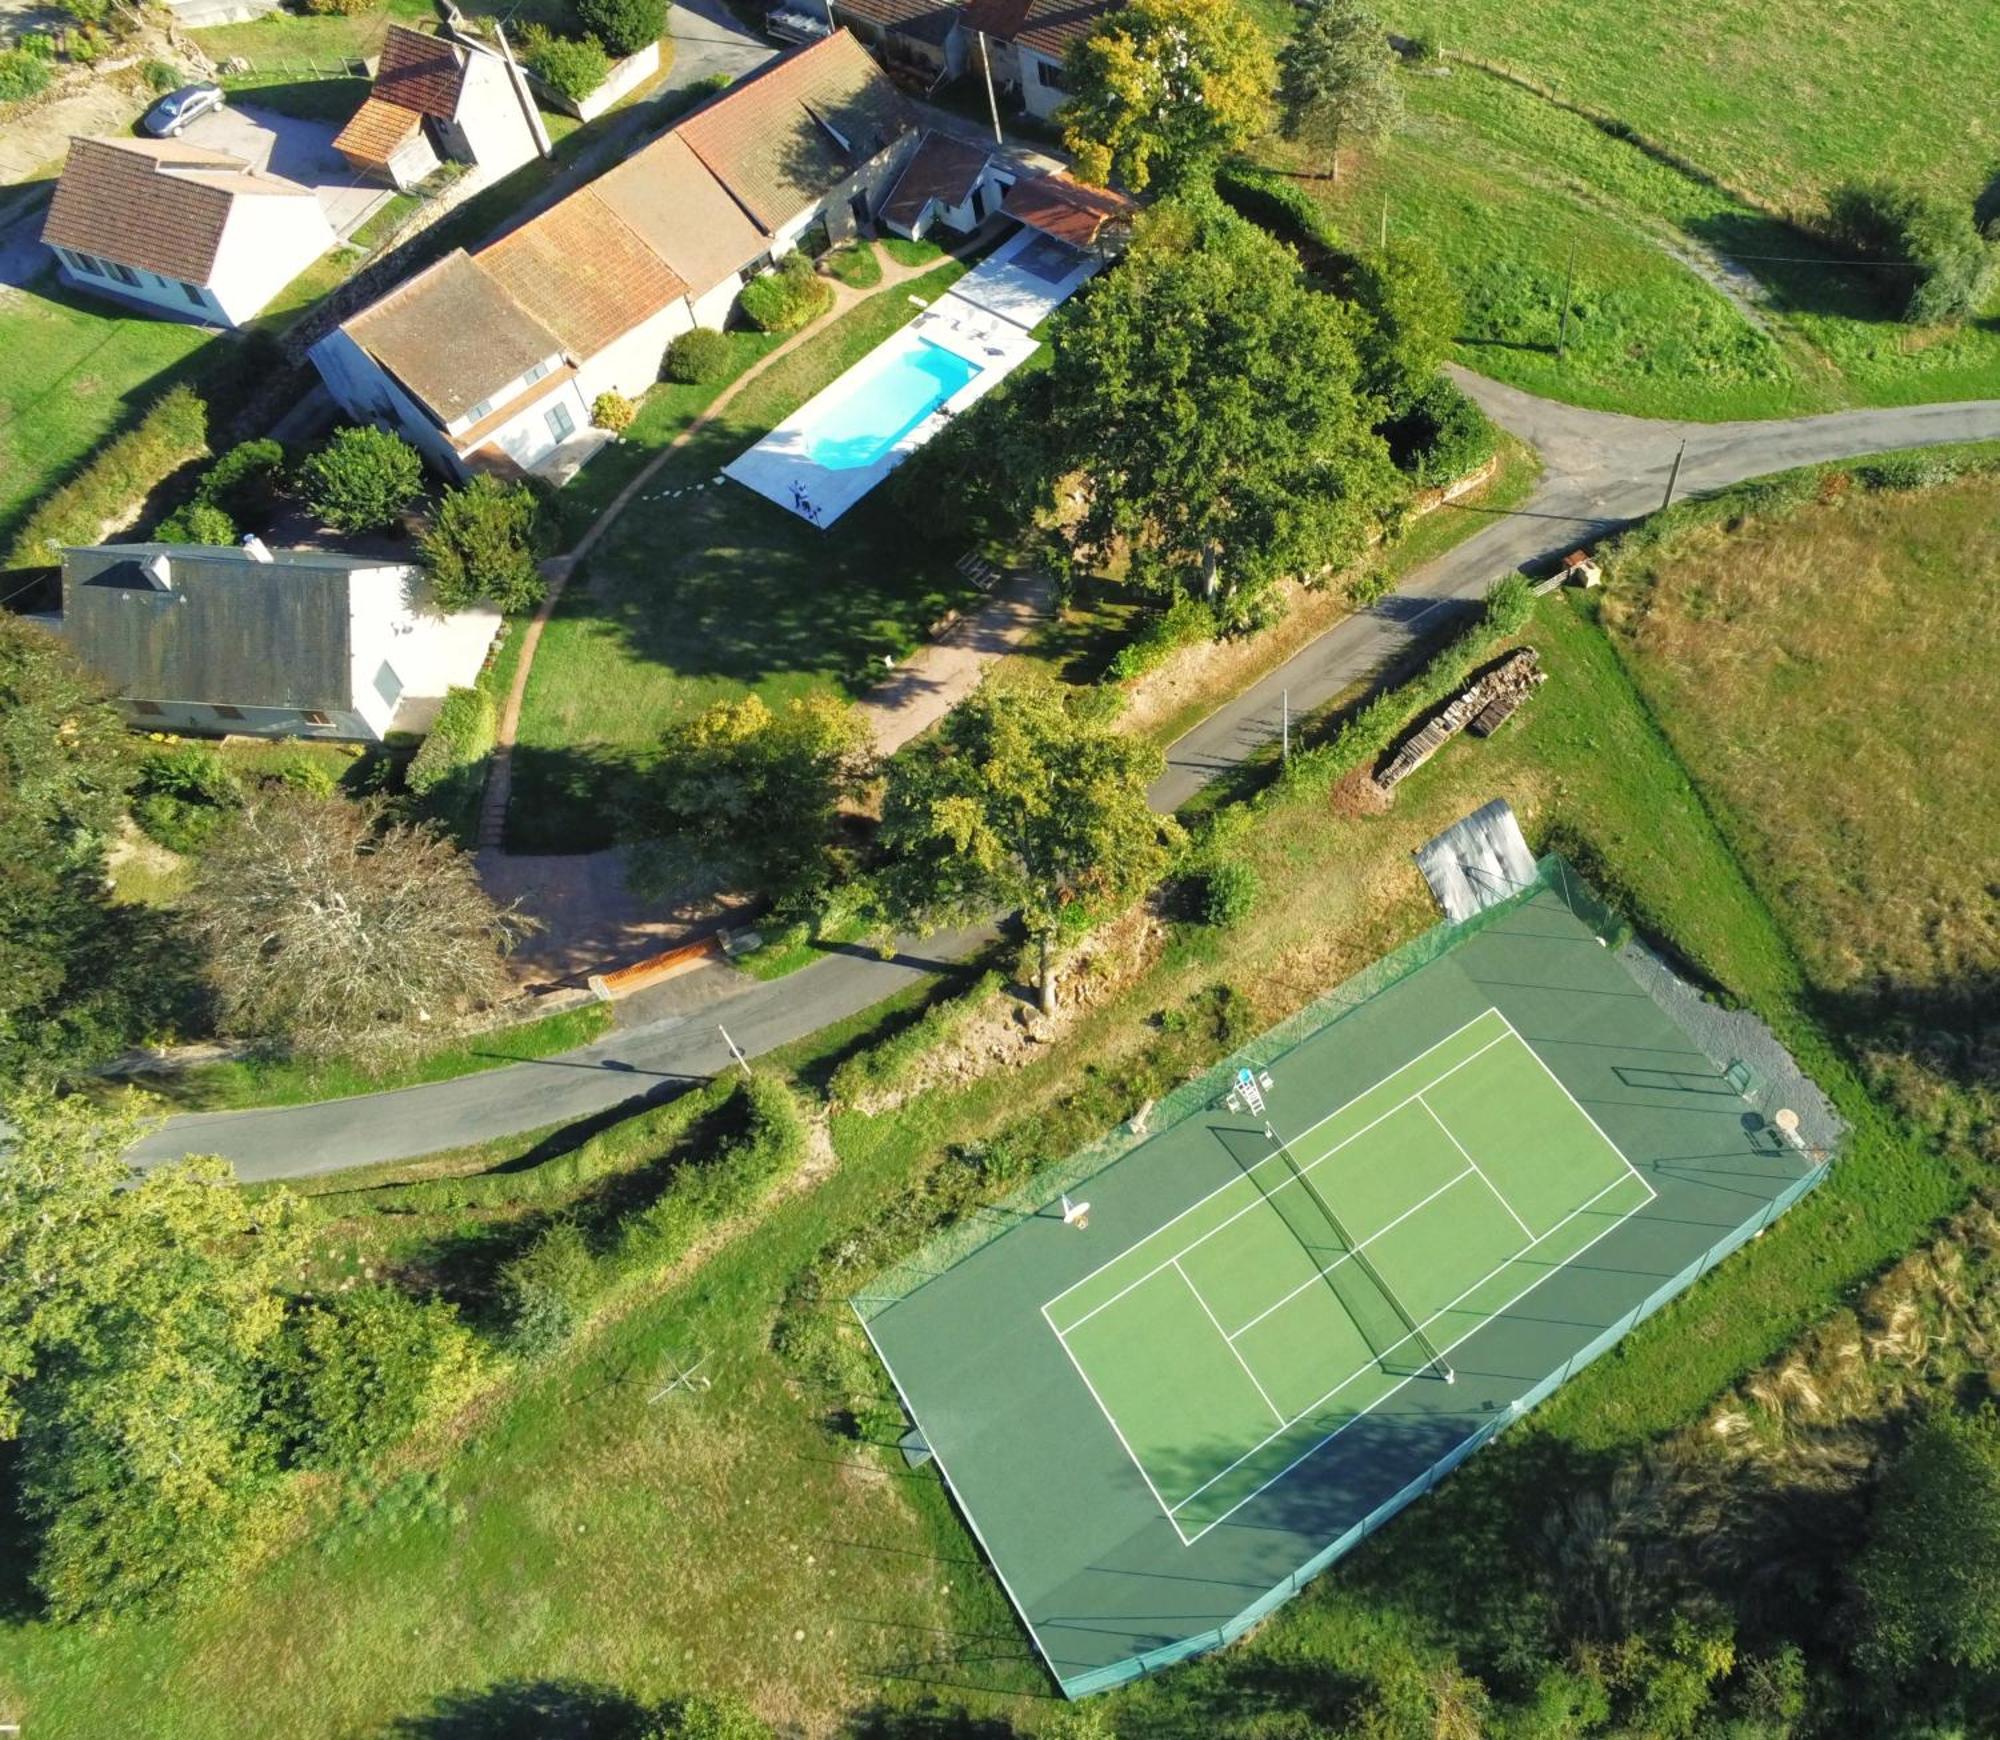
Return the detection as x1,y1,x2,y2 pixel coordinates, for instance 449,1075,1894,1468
1058,0,1276,192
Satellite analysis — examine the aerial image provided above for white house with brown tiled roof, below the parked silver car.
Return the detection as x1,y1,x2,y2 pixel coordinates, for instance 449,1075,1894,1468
42,138,334,326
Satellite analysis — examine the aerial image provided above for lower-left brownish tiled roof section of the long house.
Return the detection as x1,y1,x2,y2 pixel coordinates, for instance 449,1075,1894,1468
340,248,562,422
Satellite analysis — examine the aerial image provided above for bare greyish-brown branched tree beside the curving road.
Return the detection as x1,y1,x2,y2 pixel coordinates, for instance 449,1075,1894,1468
186,796,534,1056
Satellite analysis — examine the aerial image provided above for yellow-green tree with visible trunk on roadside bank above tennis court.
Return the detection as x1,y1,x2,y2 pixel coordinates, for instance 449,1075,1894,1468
880,676,1180,1010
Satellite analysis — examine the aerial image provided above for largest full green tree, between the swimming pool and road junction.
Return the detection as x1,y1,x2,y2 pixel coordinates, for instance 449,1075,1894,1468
1046,196,1402,594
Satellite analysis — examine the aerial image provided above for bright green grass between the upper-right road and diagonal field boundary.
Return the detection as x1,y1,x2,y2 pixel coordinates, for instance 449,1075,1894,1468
1272,66,2000,420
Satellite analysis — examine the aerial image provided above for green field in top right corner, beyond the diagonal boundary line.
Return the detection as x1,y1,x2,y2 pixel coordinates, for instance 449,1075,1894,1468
1382,0,2000,210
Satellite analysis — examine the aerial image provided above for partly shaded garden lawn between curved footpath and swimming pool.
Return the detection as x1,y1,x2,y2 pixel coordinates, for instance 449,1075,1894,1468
508,262,980,852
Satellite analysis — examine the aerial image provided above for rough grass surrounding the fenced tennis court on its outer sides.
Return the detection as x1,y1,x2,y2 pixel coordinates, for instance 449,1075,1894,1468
0,500,1964,1740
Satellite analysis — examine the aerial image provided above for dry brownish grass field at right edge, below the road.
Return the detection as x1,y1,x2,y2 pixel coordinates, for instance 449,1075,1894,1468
1606,474,2000,1120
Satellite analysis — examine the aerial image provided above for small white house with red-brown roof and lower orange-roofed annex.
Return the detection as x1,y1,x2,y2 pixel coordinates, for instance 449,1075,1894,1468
334,24,550,188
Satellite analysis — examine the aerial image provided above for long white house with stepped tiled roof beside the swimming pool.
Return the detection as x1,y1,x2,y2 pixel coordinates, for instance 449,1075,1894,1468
310,30,916,480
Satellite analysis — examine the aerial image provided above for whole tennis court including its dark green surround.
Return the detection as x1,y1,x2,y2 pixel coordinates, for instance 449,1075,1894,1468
854,860,1824,1696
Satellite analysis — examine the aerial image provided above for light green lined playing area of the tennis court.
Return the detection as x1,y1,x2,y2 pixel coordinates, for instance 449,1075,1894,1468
1042,1010,1654,1544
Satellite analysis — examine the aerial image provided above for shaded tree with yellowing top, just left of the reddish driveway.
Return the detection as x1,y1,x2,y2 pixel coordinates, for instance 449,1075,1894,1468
626,694,870,900
